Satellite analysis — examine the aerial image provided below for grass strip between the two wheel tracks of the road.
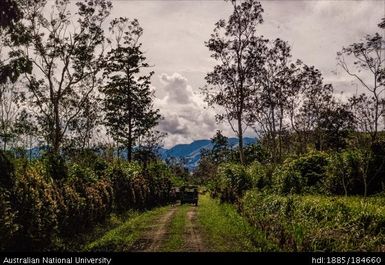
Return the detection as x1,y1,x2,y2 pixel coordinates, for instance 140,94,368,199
160,205,191,252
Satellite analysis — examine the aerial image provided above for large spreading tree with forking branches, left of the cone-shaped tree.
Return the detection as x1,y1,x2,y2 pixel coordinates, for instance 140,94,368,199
11,0,112,155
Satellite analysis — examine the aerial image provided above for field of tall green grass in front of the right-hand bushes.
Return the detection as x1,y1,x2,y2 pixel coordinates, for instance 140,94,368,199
241,191,385,251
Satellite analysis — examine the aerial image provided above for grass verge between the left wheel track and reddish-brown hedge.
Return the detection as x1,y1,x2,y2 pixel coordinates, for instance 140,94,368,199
83,206,170,252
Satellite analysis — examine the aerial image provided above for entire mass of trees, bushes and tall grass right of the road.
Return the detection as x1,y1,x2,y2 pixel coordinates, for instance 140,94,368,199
194,0,385,251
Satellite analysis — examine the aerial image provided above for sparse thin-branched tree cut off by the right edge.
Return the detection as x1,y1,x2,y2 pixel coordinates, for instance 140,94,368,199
337,33,385,143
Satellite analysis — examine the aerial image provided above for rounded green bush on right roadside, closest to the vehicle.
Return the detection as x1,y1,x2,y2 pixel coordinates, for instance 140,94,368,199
216,163,252,203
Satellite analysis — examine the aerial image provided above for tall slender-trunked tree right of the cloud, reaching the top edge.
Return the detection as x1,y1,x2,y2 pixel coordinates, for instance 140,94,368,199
202,0,263,163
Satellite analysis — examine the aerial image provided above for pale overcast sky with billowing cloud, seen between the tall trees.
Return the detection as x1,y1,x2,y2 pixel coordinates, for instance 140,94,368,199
106,0,384,147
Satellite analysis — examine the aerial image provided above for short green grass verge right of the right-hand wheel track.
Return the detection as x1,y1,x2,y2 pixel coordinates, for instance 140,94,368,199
197,195,275,252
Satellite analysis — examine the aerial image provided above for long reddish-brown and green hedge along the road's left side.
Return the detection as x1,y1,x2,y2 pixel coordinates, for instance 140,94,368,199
0,157,172,251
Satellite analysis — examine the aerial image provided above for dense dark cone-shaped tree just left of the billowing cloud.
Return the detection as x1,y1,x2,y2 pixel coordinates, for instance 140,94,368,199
103,18,160,161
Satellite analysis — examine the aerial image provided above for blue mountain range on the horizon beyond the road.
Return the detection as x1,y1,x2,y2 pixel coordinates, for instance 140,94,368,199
159,137,257,170
